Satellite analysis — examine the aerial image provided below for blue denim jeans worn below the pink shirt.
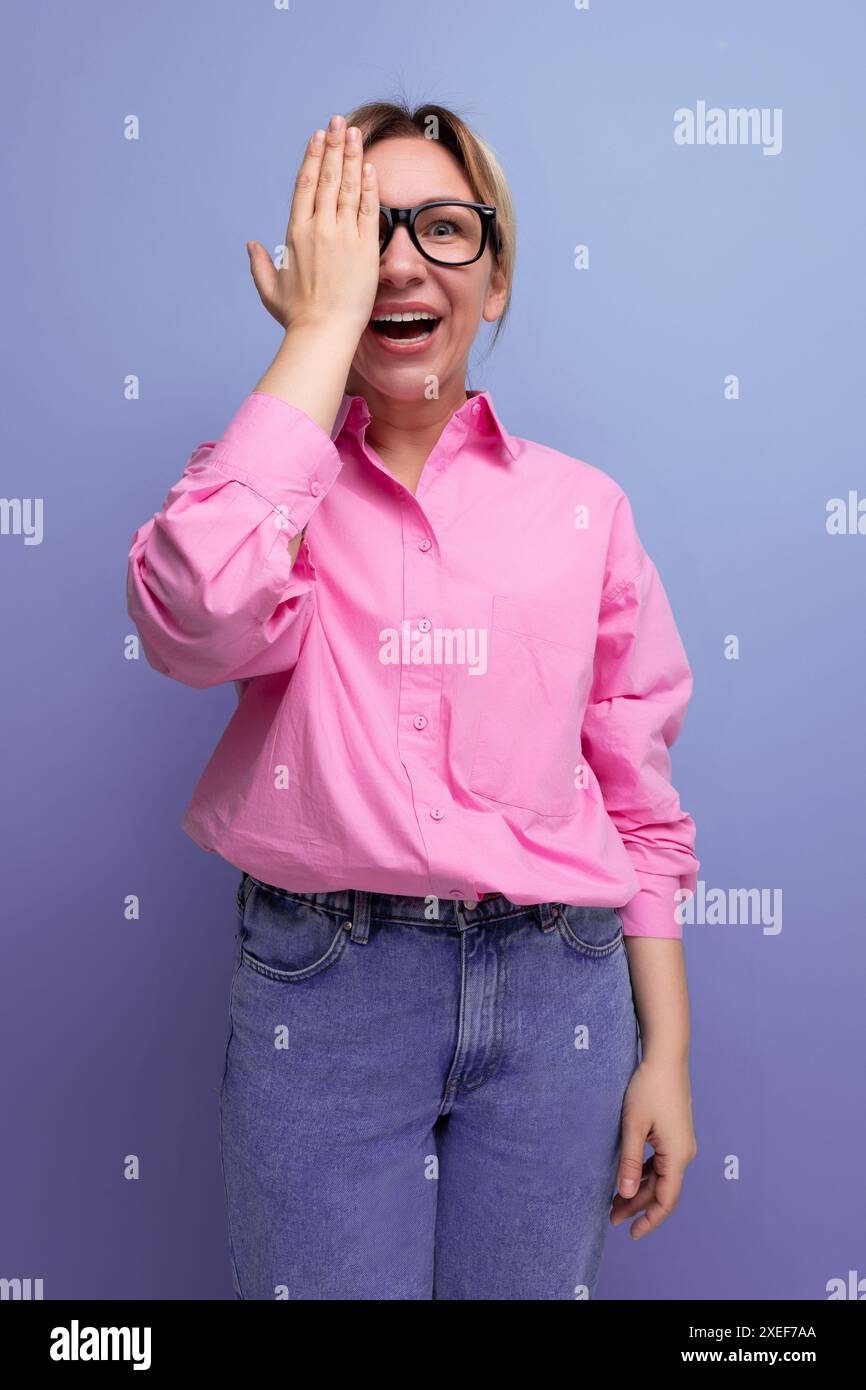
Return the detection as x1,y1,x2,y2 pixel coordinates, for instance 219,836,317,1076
220,874,638,1300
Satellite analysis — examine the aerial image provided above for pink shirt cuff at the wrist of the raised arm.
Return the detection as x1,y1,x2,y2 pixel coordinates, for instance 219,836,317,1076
209,391,343,539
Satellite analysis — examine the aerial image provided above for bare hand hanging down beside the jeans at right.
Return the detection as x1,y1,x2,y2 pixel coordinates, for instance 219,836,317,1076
610,1056,698,1240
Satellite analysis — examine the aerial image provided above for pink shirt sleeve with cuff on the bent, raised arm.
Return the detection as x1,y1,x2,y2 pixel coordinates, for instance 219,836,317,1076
126,392,342,687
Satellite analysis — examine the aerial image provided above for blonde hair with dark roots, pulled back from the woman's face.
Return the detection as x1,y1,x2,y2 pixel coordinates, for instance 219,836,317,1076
343,101,517,349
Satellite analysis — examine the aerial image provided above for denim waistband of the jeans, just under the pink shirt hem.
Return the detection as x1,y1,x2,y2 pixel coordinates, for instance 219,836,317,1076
240,874,552,926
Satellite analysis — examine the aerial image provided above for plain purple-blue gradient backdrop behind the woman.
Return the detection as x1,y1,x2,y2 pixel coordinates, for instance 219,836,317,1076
0,0,866,1300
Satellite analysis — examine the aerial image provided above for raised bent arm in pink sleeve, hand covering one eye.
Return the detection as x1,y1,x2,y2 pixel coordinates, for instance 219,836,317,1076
126,118,378,688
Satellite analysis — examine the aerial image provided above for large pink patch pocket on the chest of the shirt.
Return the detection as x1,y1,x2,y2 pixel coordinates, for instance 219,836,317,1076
468,594,595,816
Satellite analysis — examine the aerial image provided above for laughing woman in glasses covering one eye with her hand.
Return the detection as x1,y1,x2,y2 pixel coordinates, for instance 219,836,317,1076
128,103,698,1300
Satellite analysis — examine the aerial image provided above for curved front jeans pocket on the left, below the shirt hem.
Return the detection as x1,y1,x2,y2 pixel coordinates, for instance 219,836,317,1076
240,874,352,984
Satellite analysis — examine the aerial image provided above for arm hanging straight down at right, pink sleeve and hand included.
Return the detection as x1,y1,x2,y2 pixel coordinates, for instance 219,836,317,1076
581,493,701,1238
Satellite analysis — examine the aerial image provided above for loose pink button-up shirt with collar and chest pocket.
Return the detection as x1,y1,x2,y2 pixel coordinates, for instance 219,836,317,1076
128,391,699,937
